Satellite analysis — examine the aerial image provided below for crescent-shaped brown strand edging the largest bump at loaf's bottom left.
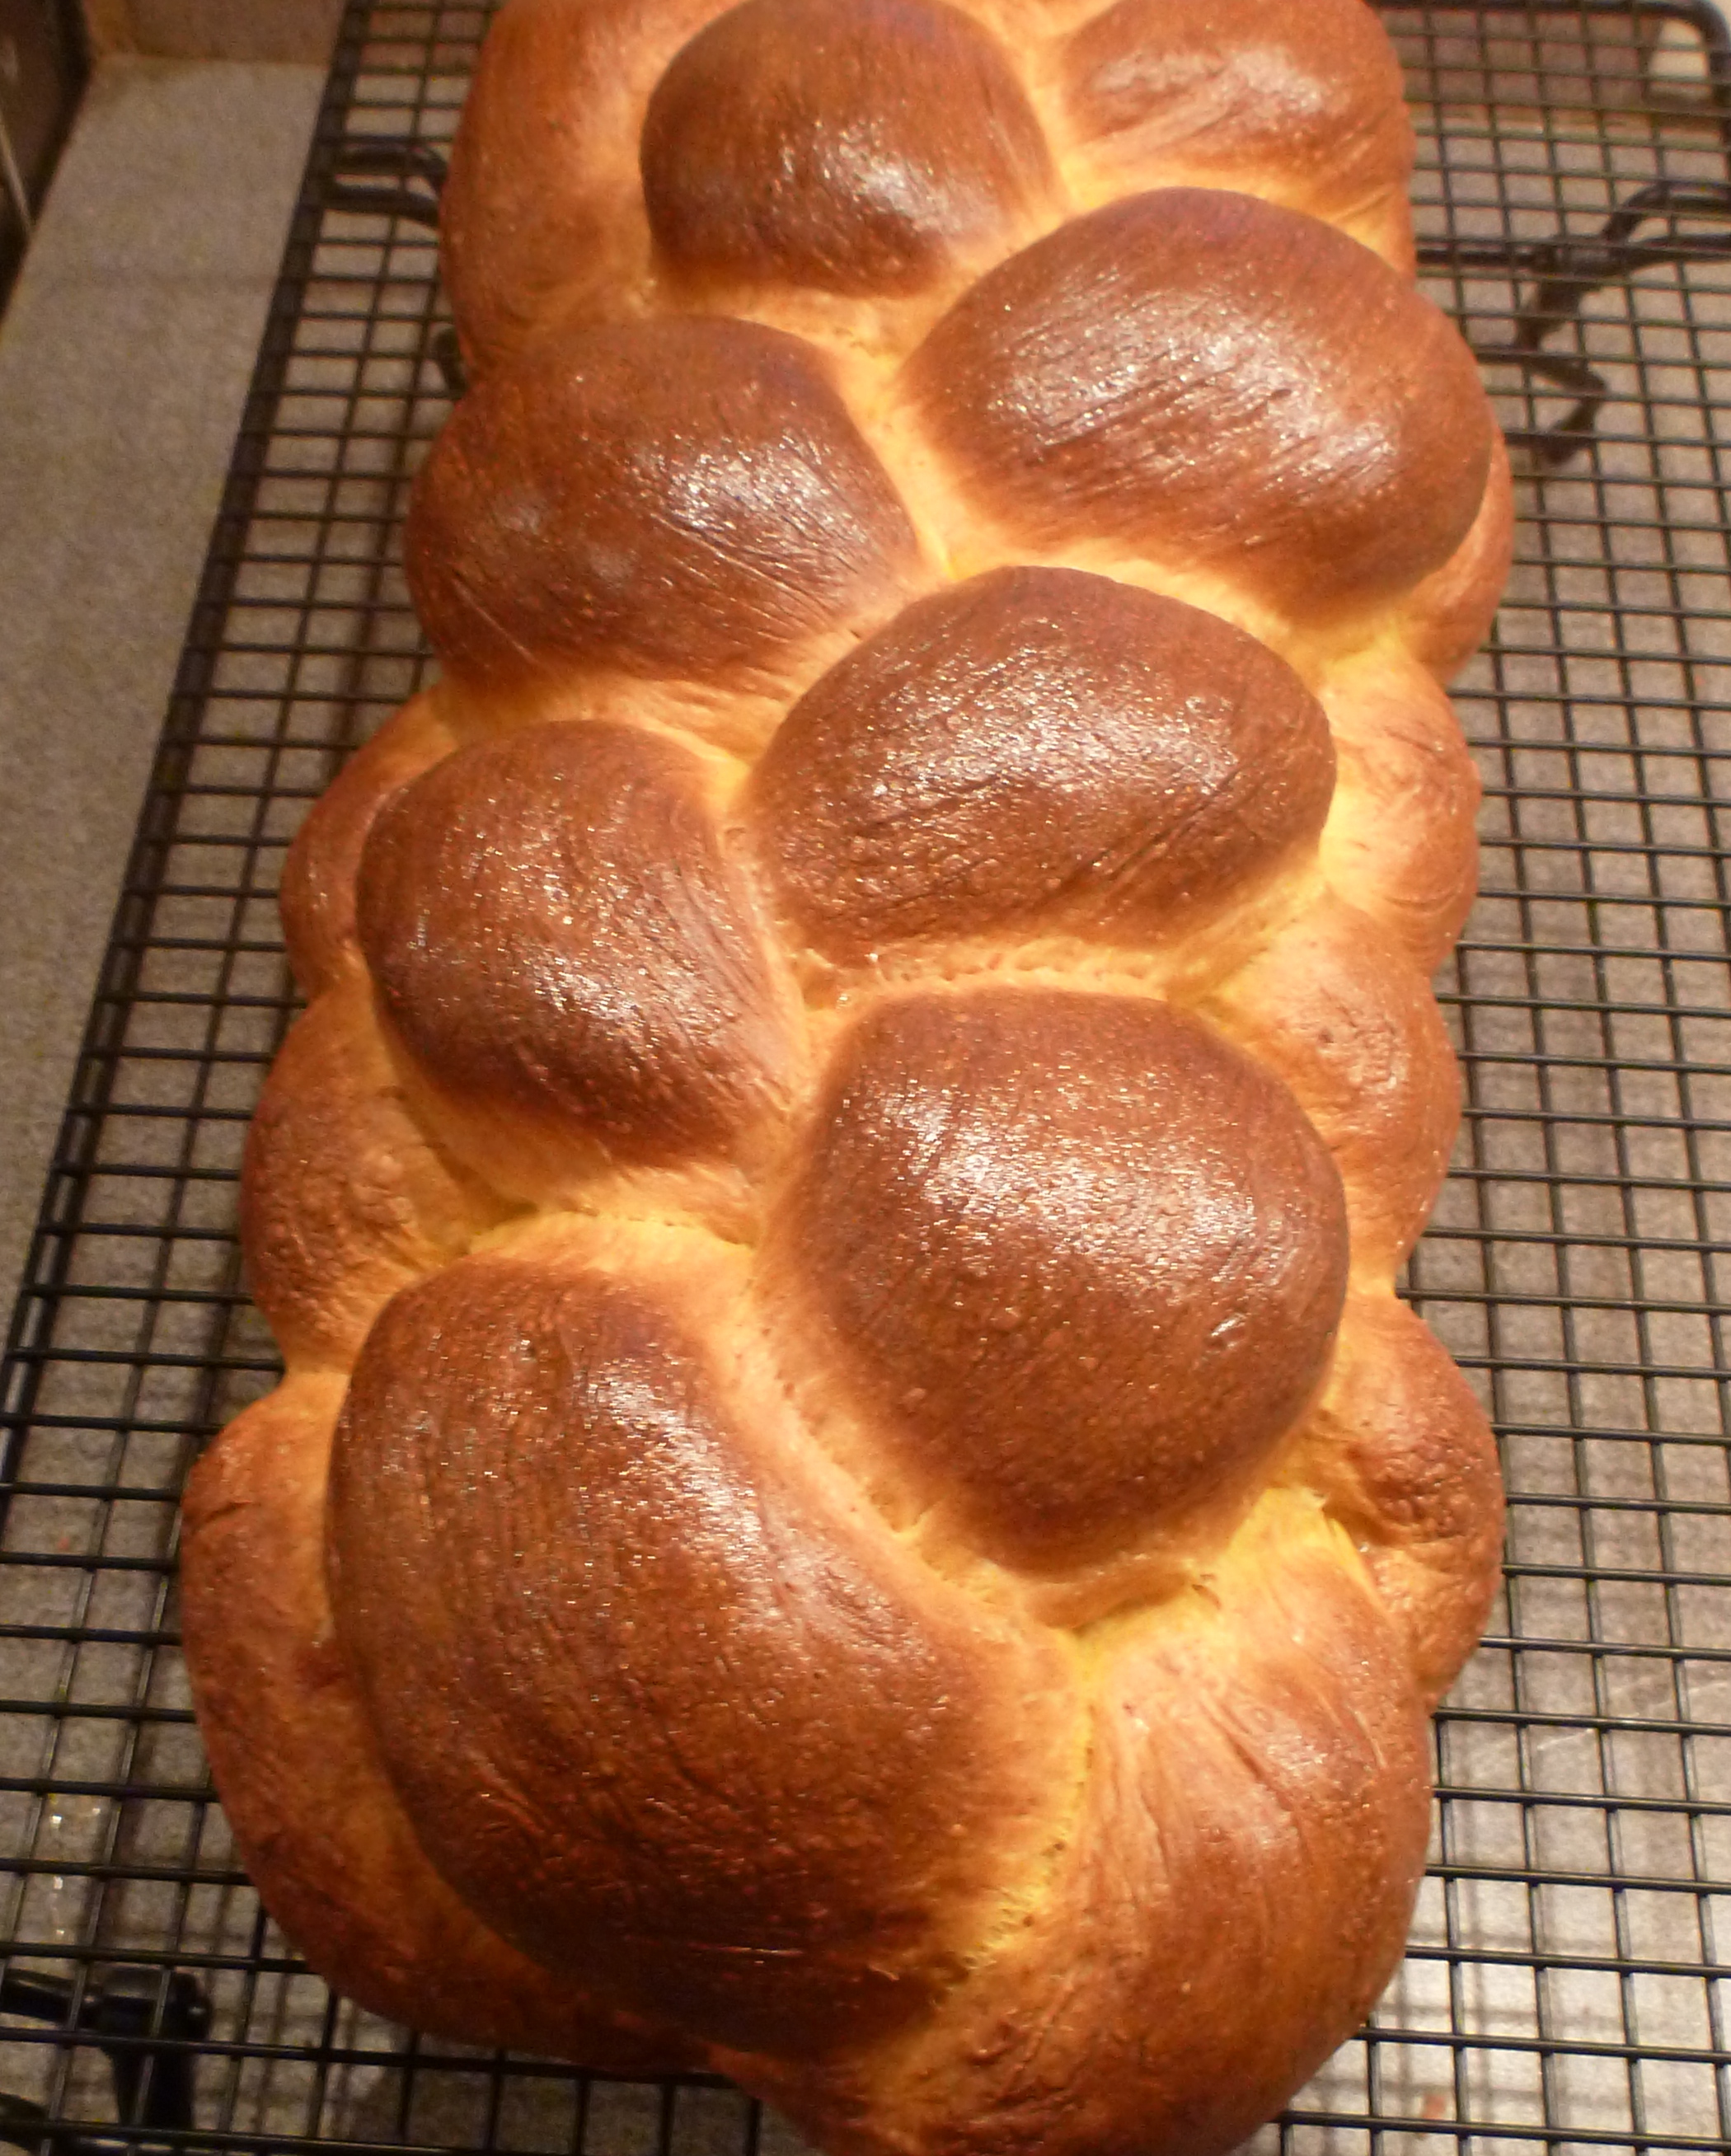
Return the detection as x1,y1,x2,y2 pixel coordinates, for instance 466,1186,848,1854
181,1373,692,2074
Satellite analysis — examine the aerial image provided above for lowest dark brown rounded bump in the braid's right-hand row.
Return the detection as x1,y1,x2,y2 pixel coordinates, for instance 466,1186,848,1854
770,987,1347,1572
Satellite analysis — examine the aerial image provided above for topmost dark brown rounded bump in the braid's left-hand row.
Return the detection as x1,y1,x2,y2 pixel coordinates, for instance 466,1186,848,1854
642,0,1050,293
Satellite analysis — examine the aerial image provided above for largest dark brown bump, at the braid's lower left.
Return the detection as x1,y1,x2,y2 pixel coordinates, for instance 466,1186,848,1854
330,1242,1076,2052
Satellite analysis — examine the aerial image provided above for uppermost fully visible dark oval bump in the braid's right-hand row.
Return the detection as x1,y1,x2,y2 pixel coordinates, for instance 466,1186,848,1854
903,188,1492,619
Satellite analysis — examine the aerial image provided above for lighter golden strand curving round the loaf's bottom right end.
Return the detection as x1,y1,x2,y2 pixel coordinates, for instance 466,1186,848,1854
748,1505,1429,2156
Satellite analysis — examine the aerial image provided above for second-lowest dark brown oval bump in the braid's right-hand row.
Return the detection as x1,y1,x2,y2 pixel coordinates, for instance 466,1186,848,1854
748,569,1335,962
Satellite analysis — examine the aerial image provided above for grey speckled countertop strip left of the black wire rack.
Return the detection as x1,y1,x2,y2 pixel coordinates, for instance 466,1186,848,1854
0,59,323,1311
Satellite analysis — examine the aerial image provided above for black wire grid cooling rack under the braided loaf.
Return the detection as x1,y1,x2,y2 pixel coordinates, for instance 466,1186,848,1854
0,0,1731,2156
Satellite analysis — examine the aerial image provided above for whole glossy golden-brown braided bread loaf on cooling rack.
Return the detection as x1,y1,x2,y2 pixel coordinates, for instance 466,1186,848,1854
185,0,1509,2156
